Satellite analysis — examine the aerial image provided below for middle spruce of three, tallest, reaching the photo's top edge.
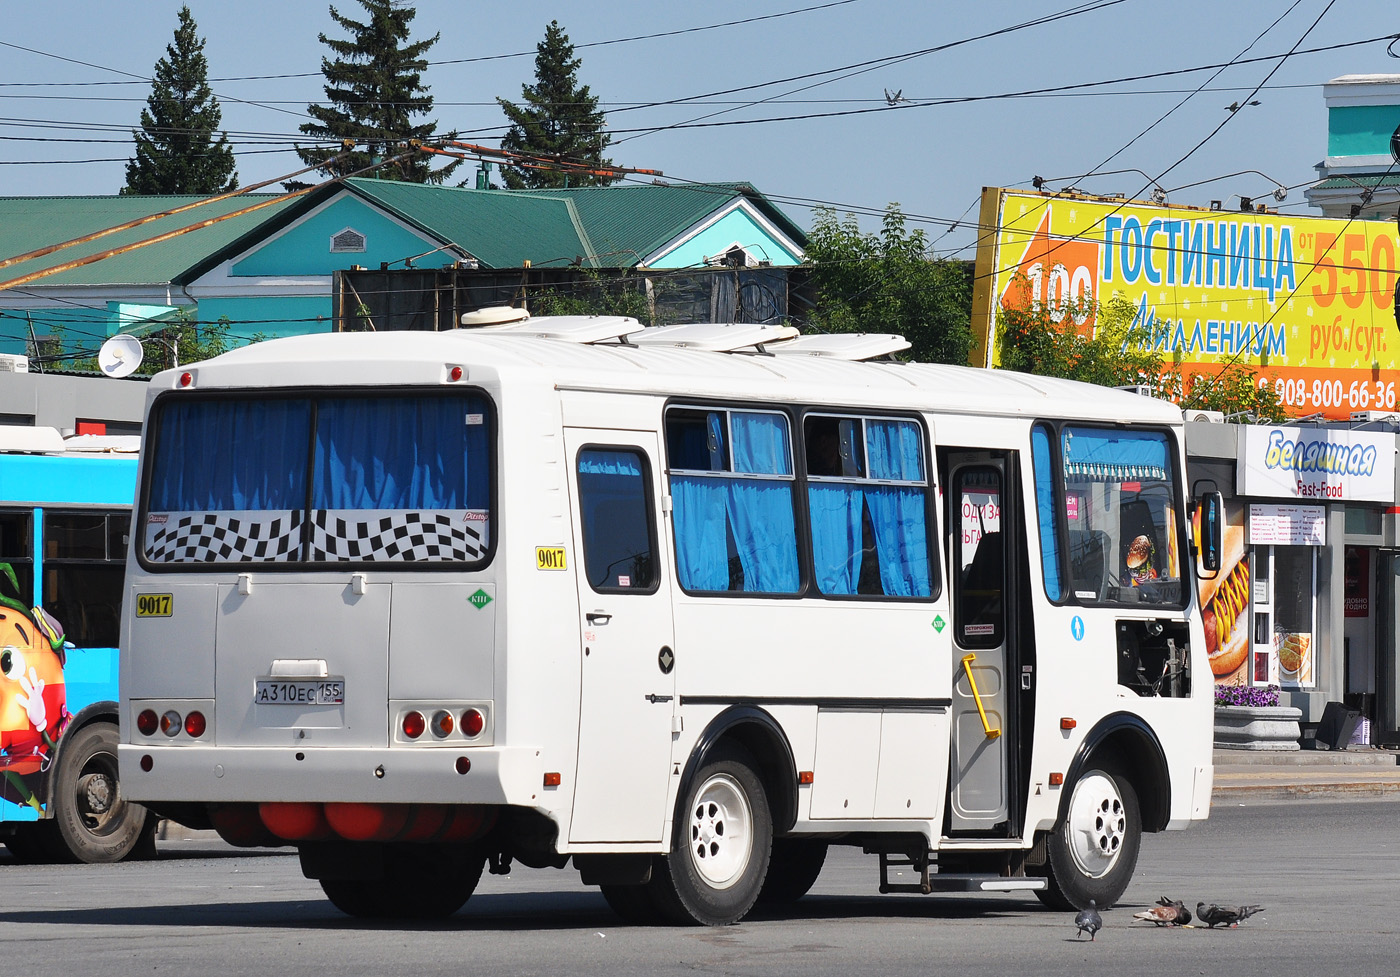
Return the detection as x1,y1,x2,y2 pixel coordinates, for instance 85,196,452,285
297,0,462,183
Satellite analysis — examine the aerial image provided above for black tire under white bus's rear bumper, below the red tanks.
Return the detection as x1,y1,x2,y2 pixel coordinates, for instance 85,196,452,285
321,845,486,920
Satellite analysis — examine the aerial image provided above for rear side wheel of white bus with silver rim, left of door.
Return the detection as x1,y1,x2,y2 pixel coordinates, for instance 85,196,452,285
648,746,773,927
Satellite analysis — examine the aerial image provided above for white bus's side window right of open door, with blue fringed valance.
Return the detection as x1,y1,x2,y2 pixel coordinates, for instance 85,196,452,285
1036,426,1183,605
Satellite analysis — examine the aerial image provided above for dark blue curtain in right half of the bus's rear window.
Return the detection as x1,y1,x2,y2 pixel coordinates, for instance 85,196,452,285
311,398,490,509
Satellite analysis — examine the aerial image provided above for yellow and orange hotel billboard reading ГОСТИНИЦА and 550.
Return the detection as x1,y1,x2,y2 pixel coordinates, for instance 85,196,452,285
972,188,1400,420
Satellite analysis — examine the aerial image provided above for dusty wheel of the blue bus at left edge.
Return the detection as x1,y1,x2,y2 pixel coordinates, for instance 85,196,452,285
43,722,148,864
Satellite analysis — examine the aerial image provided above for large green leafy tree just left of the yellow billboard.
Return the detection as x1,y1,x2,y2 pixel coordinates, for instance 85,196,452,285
806,204,972,363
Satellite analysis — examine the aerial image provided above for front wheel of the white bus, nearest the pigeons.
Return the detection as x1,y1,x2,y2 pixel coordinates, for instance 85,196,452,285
1036,768,1142,910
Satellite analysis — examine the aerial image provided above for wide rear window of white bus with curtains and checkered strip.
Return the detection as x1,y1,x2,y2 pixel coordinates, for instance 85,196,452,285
143,395,491,564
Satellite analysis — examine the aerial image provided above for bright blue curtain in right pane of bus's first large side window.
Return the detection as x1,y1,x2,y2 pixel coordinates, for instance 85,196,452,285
724,479,799,593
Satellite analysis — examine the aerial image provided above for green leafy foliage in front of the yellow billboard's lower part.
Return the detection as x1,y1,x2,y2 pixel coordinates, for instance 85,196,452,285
997,276,1284,421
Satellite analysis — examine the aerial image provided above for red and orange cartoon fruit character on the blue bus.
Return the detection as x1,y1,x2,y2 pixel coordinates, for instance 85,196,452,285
0,563,70,810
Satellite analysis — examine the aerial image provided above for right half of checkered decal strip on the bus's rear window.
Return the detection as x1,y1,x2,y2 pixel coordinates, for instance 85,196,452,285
311,509,486,563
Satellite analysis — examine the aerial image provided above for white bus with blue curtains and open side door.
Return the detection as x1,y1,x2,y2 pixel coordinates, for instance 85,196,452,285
119,318,1215,925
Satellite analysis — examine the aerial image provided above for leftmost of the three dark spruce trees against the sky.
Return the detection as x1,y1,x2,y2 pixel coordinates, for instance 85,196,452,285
122,7,238,193
